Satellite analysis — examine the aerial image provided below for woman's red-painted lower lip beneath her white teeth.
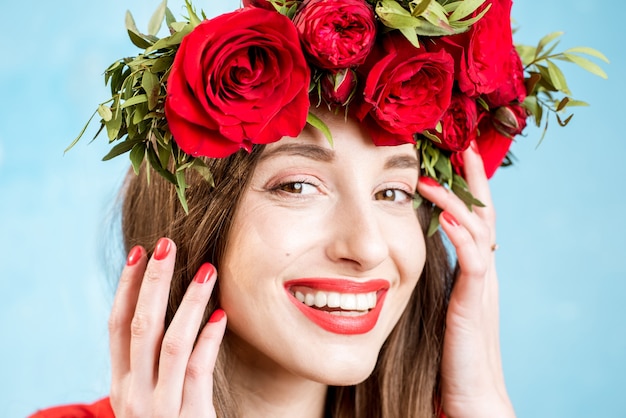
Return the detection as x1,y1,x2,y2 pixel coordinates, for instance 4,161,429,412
287,290,387,335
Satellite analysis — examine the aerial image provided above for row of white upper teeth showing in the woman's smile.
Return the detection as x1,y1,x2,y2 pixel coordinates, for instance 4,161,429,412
290,286,378,316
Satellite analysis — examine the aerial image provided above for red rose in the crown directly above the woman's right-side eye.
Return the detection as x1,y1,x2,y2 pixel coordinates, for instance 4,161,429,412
355,31,454,145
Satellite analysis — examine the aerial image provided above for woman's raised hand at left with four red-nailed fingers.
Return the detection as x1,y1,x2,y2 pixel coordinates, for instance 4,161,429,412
109,238,226,417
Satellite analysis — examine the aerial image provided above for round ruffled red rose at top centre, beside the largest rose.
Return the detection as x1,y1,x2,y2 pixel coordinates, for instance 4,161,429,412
293,0,376,70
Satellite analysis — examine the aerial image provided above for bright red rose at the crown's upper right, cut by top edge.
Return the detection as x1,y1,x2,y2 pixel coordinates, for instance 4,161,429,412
427,0,513,97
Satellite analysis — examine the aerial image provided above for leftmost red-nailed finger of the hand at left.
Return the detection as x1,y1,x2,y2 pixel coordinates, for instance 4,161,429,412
109,246,148,382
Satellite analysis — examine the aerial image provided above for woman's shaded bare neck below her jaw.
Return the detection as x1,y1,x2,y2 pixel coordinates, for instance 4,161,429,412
228,341,328,418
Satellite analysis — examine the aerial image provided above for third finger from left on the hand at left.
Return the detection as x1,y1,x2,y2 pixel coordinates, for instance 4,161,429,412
156,263,217,406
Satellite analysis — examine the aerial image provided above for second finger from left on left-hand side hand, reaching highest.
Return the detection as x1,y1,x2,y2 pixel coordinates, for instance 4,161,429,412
130,238,176,388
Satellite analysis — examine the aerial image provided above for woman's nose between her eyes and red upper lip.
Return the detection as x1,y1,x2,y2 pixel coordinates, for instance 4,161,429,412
326,201,389,271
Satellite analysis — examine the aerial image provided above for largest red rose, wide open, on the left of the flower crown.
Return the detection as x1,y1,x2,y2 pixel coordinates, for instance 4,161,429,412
165,7,310,158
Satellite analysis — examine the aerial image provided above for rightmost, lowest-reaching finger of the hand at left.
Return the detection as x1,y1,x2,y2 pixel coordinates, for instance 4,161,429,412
182,309,226,417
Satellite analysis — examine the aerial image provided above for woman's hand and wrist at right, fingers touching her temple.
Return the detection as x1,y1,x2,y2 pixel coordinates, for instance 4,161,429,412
418,143,515,418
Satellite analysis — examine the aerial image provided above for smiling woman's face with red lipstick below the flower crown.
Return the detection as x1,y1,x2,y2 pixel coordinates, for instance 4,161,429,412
219,108,425,385
